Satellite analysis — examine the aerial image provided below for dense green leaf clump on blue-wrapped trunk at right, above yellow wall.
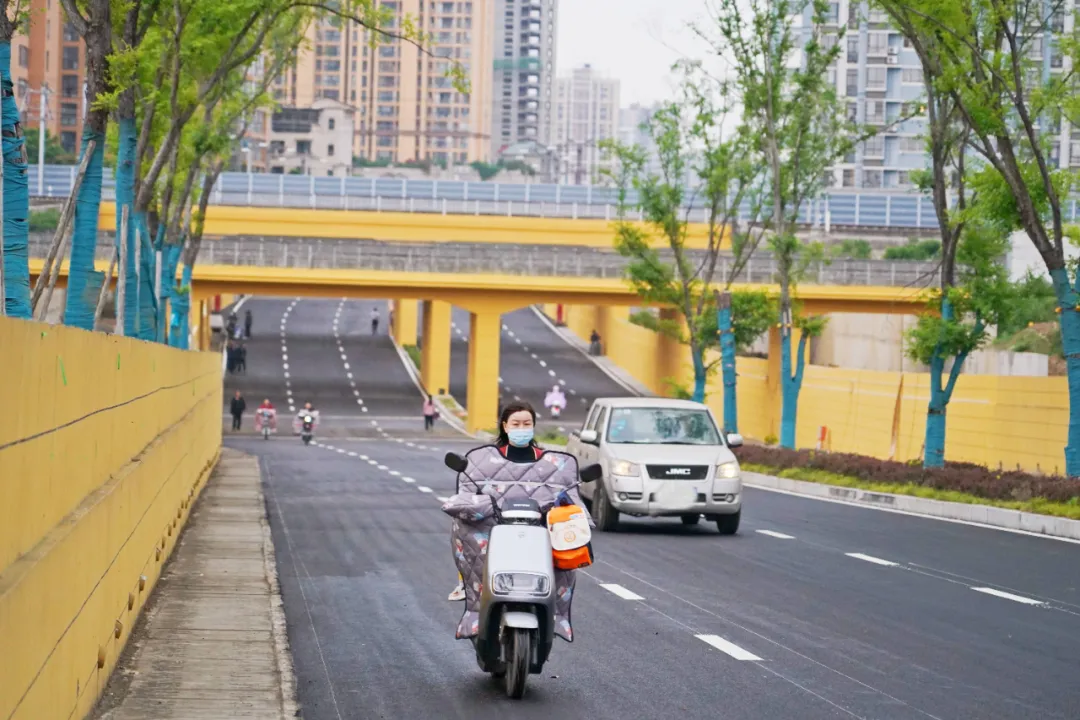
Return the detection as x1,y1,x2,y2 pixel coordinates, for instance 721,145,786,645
906,222,1013,365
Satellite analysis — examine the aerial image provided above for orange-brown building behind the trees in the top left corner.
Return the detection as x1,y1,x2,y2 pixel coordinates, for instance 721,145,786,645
11,0,86,156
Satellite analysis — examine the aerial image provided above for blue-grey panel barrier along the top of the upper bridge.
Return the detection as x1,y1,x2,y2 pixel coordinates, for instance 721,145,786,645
16,165,1006,232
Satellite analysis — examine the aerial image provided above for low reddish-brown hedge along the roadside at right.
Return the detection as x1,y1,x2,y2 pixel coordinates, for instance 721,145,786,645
735,445,1080,502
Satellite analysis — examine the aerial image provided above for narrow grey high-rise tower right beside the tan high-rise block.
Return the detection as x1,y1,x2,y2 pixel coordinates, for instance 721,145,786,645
491,0,558,157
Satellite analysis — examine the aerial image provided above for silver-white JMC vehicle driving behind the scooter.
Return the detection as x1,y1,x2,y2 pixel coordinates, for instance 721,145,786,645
567,397,742,535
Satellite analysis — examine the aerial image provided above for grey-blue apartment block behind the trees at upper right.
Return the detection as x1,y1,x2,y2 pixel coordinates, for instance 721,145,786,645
816,0,1080,189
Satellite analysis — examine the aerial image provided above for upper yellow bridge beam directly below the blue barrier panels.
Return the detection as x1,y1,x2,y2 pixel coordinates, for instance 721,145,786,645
98,203,730,248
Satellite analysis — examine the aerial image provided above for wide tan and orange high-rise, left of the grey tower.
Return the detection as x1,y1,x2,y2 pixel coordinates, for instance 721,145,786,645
274,0,496,164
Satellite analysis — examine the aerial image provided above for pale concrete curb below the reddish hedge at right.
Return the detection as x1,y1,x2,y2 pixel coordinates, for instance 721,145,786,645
743,472,1080,543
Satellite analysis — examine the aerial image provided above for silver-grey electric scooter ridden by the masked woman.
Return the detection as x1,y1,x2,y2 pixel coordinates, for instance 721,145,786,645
445,452,603,699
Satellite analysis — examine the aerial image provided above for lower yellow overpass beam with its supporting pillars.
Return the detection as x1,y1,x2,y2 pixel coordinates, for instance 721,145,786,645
30,259,926,431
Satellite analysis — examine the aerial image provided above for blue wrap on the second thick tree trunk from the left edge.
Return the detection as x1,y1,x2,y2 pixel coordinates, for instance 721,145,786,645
64,127,105,330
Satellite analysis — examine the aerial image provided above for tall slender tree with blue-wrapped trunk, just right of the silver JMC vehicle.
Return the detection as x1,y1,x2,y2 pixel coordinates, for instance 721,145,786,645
699,0,860,448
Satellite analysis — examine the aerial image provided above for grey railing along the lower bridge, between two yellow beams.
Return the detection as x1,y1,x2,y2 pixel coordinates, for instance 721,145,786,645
23,233,939,287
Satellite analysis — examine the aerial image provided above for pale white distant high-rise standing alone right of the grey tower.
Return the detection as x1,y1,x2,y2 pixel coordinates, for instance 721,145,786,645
552,65,619,185
